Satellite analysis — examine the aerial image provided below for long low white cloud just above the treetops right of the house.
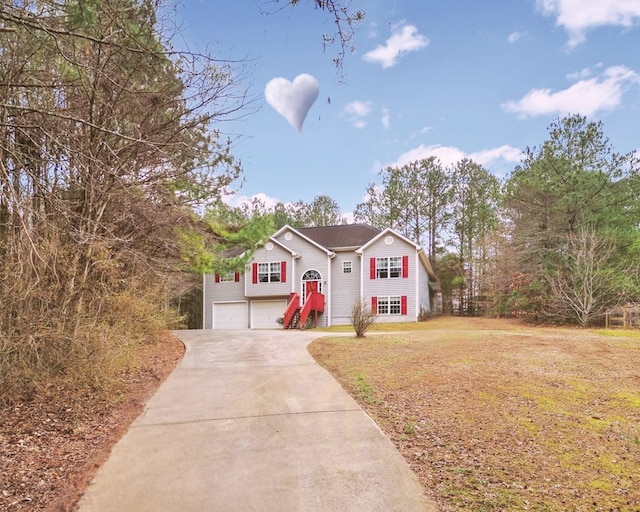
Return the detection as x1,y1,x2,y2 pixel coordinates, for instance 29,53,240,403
387,144,523,167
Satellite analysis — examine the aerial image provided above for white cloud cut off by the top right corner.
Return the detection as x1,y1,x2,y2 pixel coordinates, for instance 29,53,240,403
537,0,640,48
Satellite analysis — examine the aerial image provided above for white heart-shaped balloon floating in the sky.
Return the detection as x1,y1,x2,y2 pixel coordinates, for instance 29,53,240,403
264,73,320,133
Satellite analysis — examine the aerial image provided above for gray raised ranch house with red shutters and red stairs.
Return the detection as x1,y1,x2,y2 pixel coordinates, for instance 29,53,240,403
203,224,436,329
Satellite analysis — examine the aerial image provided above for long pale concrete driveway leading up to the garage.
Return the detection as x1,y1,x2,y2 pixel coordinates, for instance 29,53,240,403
74,330,437,512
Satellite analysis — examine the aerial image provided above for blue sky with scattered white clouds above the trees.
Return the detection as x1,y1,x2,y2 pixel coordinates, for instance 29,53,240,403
173,0,640,218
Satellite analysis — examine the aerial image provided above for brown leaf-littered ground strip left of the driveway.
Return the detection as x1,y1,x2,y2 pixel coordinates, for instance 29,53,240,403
0,334,184,512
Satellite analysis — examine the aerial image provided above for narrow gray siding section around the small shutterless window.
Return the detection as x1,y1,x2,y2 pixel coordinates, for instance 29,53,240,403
331,251,361,325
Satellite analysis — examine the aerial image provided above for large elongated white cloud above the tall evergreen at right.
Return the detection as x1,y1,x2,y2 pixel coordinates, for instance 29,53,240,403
502,66,640,117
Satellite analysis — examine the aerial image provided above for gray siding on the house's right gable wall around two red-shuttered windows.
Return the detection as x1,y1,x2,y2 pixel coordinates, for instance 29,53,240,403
362,235,418,322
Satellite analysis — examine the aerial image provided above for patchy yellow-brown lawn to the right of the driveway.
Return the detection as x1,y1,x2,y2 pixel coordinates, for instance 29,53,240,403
309,318,640,511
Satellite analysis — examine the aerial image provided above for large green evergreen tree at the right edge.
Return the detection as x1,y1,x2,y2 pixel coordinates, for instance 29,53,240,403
504,115,640,322
